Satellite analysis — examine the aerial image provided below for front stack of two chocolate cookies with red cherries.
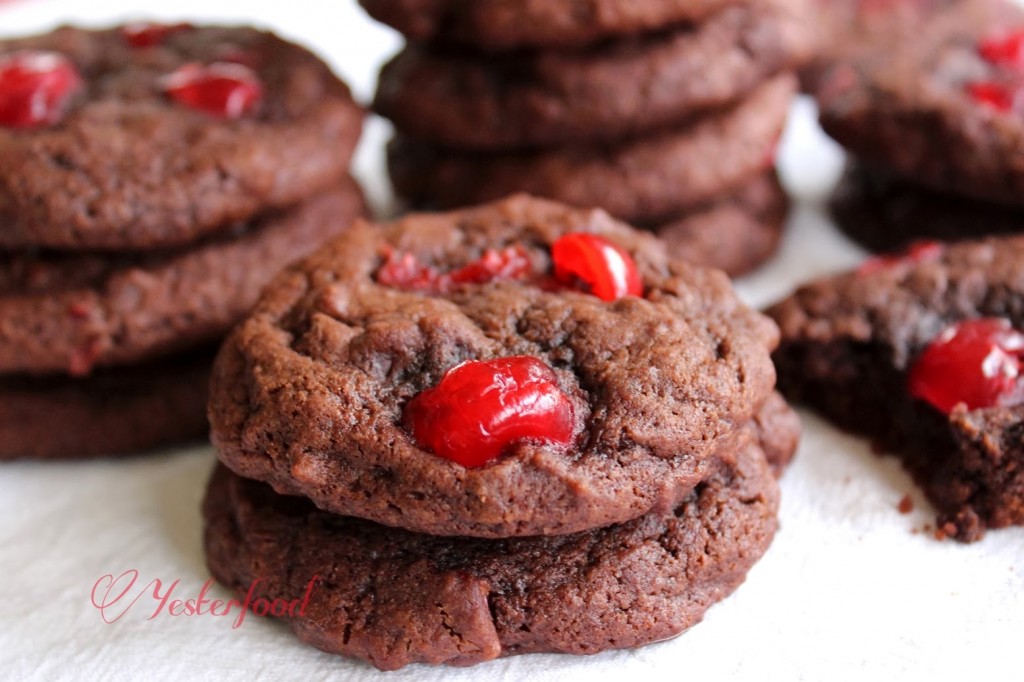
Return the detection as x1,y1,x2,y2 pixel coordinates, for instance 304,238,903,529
204,197,799,669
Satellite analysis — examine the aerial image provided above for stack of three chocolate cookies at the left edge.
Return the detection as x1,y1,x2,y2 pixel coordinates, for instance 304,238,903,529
0,25,364,459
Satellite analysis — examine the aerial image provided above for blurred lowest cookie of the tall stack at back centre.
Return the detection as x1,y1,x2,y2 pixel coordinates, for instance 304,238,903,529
652,172,790,276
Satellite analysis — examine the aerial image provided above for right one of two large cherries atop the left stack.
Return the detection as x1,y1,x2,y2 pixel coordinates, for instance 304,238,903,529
164,61,263,119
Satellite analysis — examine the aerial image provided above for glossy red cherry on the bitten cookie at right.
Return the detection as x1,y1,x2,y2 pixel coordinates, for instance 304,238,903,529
907,318,1024,414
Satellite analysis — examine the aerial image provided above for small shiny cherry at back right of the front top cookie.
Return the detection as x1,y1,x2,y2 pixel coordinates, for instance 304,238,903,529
551,232,643,301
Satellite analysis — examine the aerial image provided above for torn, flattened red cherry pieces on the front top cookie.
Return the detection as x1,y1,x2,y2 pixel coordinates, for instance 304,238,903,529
377,246,532,294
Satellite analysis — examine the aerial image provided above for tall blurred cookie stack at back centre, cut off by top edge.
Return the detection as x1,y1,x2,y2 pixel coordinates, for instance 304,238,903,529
361,0,813,274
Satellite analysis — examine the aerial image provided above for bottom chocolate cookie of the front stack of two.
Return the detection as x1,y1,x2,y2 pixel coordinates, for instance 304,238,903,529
203,419,778,670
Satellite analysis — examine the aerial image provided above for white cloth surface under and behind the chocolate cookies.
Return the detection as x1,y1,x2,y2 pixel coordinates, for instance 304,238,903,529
0,0,1024,681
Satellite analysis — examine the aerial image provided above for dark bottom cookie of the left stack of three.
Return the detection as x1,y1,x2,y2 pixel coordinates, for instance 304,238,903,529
0,349,213,460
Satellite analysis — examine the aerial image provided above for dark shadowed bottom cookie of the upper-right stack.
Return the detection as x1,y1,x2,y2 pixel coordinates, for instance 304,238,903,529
831,164,1024,252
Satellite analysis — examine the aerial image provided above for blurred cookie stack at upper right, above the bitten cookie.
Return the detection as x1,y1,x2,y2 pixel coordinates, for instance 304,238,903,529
817,0,1024,251
